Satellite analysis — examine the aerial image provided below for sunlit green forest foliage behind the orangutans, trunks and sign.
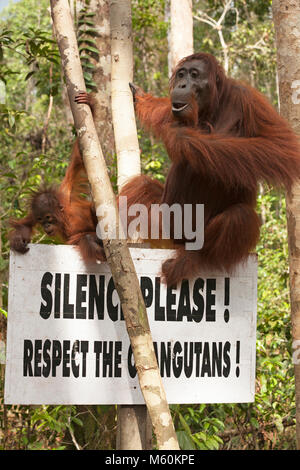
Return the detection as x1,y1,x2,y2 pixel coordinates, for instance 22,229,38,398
0,0,296,450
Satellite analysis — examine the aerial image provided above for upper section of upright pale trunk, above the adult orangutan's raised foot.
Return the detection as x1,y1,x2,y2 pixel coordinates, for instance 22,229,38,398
110,0,141,190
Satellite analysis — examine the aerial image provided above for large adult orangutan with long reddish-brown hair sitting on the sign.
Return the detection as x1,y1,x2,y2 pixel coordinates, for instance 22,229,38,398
121,53,300,285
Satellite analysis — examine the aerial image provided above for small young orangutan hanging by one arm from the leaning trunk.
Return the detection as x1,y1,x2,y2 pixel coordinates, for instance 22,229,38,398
9,93,104,262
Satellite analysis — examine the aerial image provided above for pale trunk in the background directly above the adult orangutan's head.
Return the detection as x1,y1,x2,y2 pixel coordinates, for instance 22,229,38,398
169,0,194,74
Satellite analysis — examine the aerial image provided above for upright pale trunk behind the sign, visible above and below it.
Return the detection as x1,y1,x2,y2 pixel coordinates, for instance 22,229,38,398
108,0,152,450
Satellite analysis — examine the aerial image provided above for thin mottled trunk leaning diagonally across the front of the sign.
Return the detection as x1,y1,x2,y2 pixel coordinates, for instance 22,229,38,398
51,0,179,450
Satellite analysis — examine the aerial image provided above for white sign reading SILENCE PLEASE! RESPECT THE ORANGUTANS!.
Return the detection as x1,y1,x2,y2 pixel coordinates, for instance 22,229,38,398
5,245,257,404
